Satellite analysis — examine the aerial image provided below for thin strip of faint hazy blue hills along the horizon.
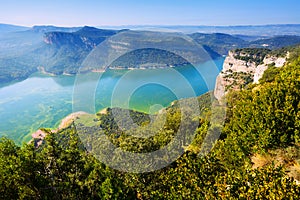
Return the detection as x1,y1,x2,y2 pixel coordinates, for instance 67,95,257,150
0,23,300,37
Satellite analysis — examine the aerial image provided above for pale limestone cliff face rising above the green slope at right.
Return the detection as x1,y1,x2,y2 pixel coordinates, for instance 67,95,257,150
214,49,287,100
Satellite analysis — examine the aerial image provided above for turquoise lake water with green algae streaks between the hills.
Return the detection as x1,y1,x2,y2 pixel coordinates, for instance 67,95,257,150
0,58,224,144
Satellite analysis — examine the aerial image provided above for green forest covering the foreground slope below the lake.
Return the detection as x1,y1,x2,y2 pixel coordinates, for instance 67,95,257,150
0,48,300,199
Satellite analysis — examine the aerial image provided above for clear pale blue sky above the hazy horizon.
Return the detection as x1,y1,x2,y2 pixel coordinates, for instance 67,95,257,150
0,0,300,26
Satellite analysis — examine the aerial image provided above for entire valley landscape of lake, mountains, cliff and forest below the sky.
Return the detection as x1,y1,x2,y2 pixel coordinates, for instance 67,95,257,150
0,25,300,199
